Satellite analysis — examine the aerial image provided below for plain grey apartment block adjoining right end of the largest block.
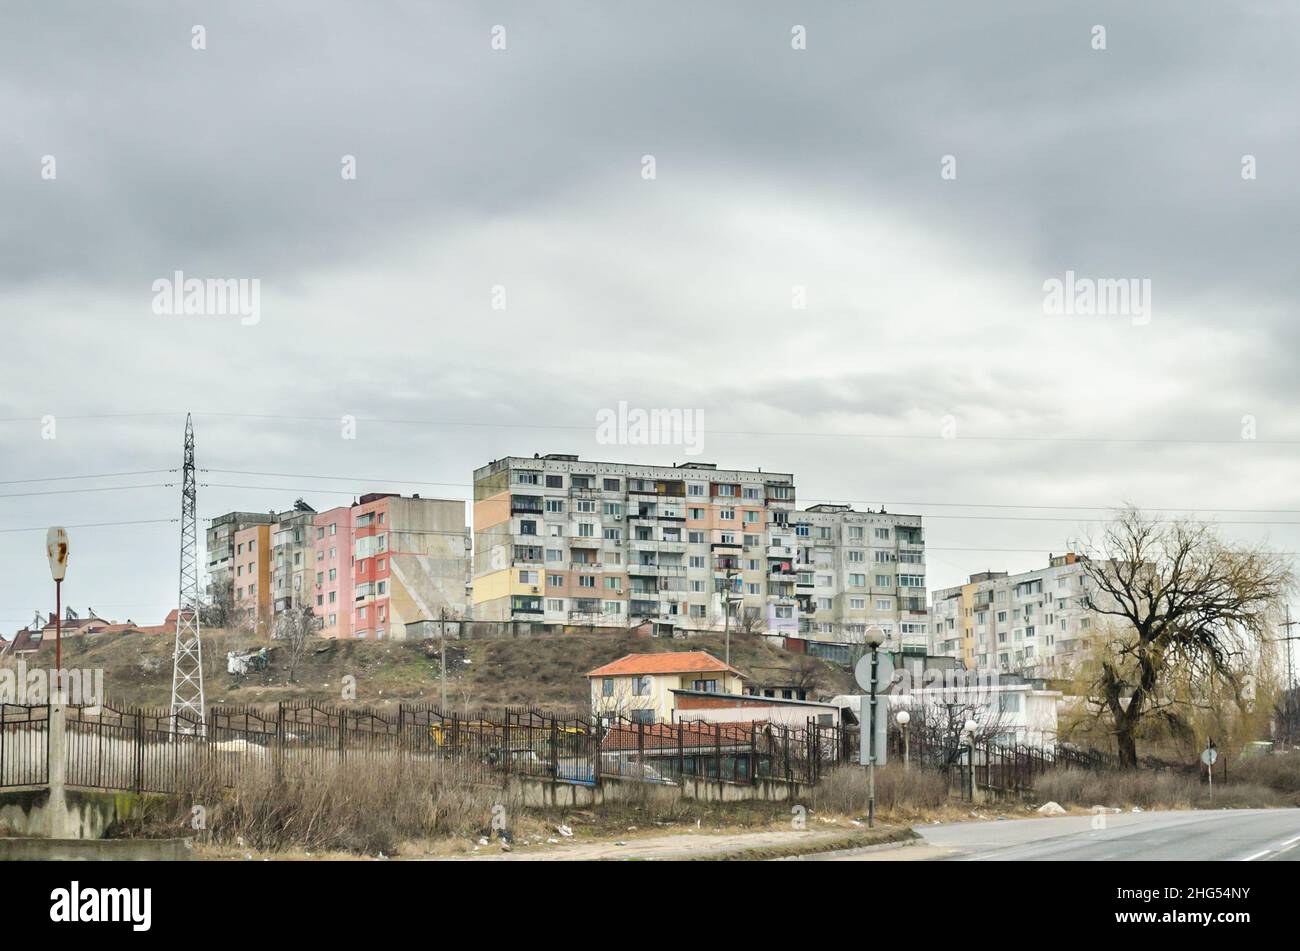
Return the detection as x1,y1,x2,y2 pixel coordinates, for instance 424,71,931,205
792,504,930,653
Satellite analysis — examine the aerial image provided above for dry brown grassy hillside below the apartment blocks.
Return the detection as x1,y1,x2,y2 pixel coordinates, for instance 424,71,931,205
15,631,854,709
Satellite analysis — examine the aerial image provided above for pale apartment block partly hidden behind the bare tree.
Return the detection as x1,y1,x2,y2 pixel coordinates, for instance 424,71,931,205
930,552,1095,677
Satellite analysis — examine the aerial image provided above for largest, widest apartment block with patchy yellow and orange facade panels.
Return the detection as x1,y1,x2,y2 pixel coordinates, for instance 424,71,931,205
473,453,798,634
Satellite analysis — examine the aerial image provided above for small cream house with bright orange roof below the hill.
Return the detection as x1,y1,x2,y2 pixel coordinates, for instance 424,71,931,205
586,651,745,724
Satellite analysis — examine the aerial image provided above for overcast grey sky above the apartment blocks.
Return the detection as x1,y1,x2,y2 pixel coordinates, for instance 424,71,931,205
0,0,1300,635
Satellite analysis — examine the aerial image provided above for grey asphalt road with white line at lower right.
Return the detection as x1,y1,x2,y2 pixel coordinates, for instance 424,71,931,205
806,809,1300,861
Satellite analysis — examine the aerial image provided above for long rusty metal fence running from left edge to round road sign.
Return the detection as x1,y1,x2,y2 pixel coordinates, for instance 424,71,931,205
0,702,855,793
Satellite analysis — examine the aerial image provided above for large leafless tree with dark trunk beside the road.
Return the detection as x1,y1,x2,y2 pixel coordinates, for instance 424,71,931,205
1084,508,1294,768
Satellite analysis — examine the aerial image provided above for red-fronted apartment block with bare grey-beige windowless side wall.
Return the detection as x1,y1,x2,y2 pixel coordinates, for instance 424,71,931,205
351,492,469,640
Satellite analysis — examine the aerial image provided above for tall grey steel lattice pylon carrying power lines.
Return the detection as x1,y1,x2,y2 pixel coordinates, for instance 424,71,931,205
172,413,207,733
